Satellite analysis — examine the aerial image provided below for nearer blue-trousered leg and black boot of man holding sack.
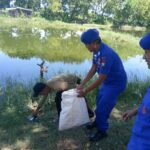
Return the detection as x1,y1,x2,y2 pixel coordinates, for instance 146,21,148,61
90,87,120,141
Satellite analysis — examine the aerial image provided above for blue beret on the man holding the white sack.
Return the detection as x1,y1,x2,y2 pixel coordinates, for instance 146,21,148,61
81,29,99,44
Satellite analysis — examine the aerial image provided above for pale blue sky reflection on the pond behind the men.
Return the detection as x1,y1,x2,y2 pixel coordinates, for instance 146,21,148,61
0,52,150,85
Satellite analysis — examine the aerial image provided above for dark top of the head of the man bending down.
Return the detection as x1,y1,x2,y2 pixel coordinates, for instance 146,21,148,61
33,82,46,97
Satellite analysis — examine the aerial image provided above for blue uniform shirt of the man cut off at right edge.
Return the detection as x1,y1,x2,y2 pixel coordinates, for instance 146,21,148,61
128,88,150,150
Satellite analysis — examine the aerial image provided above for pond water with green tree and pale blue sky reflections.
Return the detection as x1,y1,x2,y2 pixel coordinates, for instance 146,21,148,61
0,28,150,84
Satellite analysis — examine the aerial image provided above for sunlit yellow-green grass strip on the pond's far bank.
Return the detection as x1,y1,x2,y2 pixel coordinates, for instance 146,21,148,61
0,16,146,32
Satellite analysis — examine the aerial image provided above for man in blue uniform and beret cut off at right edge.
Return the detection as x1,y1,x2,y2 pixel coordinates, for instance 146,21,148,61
123,32,150,150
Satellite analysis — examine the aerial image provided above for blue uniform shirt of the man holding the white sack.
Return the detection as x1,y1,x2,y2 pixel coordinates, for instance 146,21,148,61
93,42,127,86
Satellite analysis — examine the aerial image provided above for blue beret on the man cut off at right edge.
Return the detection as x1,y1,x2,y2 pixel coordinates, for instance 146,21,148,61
139,32,150,50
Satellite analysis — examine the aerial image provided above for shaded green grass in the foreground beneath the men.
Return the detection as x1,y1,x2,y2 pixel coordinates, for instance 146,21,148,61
0,79,150,150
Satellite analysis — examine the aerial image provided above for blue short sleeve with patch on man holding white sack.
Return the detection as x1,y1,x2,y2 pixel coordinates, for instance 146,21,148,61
98,53,114,74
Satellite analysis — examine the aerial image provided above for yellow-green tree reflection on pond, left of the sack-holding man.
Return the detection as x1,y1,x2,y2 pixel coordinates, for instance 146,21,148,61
0,27,85,61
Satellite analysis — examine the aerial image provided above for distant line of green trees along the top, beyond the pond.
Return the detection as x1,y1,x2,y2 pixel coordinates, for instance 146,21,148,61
0,0,150,27
